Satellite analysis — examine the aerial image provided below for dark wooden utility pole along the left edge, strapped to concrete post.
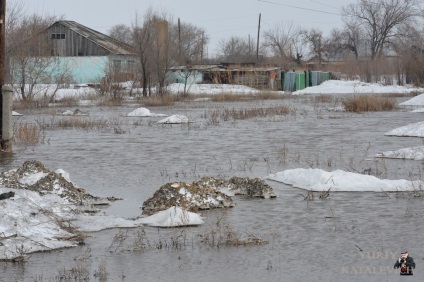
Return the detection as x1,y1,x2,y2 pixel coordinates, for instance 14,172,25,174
0,0,6,143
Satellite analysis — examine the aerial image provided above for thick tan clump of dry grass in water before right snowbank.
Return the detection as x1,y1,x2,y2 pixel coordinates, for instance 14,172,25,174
342,95,397,112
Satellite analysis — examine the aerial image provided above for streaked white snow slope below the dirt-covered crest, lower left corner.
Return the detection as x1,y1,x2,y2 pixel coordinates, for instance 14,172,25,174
0,188,84,260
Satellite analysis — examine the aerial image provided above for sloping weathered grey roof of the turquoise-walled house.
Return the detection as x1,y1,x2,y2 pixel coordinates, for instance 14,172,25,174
56,21,135,55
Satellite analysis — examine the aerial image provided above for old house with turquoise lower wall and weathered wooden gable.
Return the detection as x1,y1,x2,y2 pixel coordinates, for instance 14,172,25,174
12,21,136,84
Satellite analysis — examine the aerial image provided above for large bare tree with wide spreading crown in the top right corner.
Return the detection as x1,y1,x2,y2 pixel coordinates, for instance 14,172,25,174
342,0,420,60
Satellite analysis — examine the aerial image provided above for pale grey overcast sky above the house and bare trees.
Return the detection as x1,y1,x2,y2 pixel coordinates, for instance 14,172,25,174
18,0,357,56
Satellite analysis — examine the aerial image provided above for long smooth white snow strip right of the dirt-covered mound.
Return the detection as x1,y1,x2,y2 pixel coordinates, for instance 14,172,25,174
268,168,423,192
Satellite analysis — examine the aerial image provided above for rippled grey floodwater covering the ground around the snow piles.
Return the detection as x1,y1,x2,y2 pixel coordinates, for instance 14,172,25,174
0,93,424,282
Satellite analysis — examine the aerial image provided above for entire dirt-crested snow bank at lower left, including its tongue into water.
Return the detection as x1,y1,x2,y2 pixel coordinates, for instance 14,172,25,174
0,161,203,261
